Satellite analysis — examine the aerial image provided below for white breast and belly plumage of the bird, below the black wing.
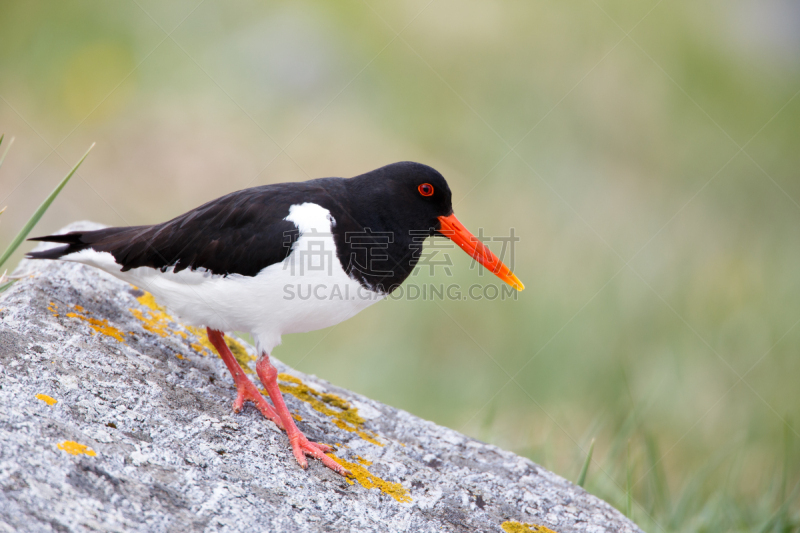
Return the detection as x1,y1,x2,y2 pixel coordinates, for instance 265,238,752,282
63,203,385,353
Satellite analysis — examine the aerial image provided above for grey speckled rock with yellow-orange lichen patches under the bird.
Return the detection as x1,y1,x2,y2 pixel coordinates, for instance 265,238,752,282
0,223,639,533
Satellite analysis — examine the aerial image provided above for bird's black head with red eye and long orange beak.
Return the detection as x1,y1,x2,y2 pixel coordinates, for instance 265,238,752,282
349,161,525,291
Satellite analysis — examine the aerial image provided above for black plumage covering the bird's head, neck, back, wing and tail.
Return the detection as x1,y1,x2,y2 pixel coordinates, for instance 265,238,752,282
28,162,452,293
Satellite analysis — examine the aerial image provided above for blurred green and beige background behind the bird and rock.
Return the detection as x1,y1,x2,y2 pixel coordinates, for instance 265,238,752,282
0,0,800,531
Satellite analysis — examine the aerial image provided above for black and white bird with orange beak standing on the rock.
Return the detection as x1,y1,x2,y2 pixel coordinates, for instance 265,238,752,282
27,161,524,475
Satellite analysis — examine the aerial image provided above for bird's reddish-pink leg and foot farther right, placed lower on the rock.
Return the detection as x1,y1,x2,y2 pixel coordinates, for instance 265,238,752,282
256,352,350,476
